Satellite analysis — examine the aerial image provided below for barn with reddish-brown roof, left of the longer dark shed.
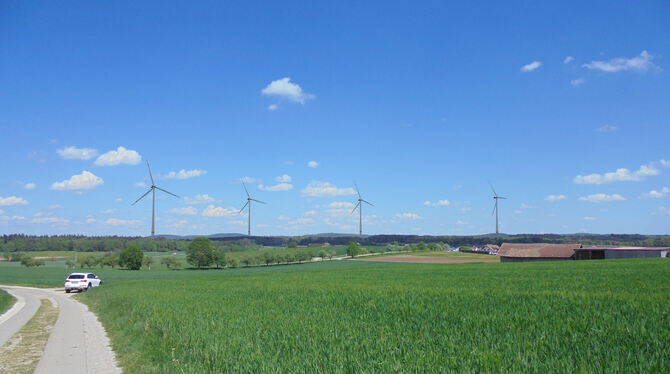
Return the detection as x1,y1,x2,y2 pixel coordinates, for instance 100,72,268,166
498,243,582,262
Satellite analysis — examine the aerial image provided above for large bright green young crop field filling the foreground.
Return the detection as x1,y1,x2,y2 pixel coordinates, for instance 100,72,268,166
80,259,670,373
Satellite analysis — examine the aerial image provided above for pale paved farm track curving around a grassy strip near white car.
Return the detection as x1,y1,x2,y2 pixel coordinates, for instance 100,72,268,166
0,286,121,374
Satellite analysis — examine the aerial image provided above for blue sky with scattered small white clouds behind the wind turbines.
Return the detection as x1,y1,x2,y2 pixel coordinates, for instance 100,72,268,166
0,1,670,235
